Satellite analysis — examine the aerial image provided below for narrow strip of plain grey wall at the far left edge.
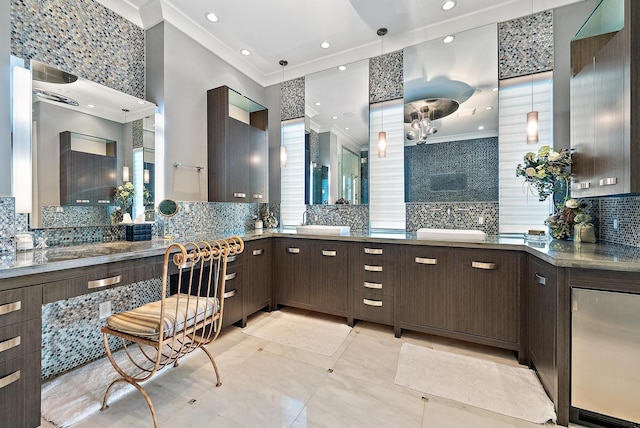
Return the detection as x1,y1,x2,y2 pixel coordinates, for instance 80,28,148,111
0,1,11,196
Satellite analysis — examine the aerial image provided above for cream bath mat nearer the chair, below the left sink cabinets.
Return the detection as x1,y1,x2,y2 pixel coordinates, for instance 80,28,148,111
242,311,351,357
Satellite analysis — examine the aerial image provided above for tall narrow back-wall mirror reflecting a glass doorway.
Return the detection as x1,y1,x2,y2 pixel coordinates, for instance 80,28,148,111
305,60,369,204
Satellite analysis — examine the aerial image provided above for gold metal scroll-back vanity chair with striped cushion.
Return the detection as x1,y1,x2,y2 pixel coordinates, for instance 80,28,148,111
101,237,244,427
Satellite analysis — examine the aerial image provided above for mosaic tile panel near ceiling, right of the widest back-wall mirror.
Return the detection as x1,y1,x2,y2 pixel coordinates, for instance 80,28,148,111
498,10,553,80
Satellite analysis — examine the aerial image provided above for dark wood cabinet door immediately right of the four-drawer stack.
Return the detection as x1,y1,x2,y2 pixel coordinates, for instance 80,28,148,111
398,246,453,330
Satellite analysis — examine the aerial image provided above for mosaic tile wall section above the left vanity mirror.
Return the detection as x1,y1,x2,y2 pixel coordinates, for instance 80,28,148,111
10,0,145,98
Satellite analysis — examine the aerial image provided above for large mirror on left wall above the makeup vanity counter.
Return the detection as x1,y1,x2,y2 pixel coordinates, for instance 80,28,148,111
31,60,156,227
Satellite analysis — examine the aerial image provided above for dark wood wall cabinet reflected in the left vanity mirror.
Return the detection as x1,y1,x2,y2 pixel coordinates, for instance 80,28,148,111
60,131,117,206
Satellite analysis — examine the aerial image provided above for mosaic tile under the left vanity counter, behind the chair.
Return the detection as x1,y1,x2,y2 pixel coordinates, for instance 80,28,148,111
41,278,162,380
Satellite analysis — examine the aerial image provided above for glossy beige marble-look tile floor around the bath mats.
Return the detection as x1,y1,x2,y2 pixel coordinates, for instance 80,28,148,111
41,309,576,428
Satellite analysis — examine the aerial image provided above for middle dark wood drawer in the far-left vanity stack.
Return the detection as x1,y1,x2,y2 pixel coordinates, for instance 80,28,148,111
0,317,42,363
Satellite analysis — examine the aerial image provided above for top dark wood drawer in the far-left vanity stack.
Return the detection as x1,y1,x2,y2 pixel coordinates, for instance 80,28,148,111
0,286,42,327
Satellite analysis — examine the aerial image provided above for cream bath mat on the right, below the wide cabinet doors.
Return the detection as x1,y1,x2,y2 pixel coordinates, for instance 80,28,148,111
395,343,556,424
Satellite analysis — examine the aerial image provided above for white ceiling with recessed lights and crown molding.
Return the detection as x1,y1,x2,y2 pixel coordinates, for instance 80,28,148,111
98,0,583,86
